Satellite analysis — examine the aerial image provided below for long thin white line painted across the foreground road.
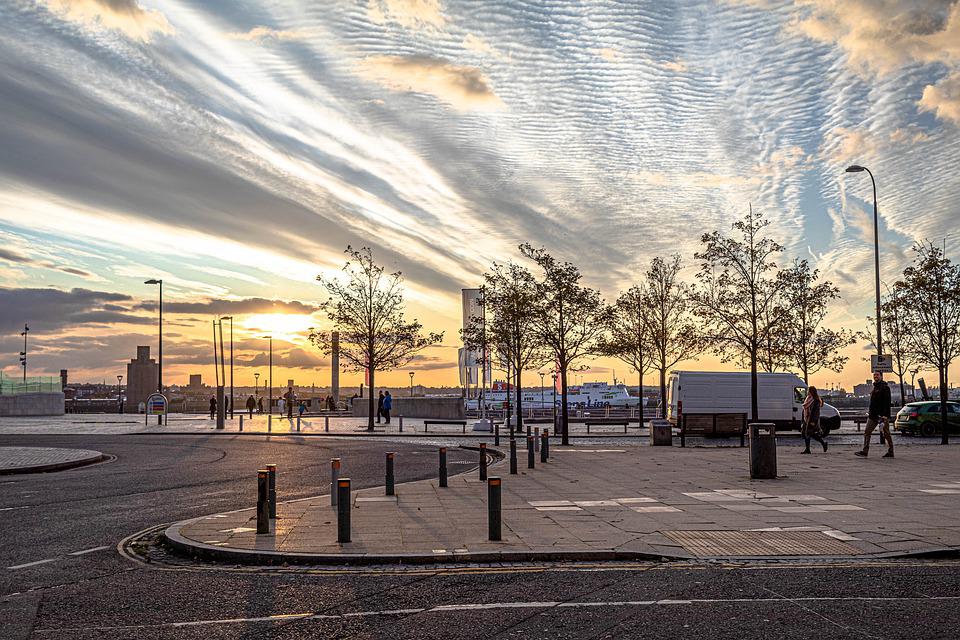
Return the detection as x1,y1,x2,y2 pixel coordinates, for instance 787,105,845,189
34,596,960,634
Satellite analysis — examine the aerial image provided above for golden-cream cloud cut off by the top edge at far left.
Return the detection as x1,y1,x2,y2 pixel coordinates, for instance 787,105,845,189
41,0,174,42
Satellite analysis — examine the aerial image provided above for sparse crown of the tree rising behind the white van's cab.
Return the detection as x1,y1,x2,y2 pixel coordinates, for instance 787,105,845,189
771,259,857,383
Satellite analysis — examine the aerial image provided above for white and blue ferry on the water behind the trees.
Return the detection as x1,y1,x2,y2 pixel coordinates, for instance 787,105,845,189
466,382,647,409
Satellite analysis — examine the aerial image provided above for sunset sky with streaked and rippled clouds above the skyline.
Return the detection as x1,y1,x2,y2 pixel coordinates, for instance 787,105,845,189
0,0,960,386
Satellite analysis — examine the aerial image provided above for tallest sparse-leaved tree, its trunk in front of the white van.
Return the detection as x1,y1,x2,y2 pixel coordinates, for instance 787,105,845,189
691,206,783,420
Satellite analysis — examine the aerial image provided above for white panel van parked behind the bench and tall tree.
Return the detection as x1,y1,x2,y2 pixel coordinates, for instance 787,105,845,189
667,371,840,432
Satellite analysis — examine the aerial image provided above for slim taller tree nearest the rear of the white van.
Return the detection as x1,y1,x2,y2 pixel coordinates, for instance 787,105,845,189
640,254,704,418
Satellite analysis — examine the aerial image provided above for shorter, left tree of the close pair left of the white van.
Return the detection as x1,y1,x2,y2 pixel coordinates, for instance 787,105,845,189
601,285,655,427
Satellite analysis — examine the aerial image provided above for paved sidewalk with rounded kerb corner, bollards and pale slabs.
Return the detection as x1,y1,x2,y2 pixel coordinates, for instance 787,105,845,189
166,446,960,563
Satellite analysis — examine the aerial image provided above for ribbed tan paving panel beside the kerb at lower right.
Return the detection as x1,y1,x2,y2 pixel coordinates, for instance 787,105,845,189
661,531,861,557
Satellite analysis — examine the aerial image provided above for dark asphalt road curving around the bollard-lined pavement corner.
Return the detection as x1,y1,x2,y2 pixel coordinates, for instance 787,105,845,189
0,436,960,640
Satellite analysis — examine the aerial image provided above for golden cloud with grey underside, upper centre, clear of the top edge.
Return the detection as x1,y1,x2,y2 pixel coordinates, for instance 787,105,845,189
352,55,503,111
